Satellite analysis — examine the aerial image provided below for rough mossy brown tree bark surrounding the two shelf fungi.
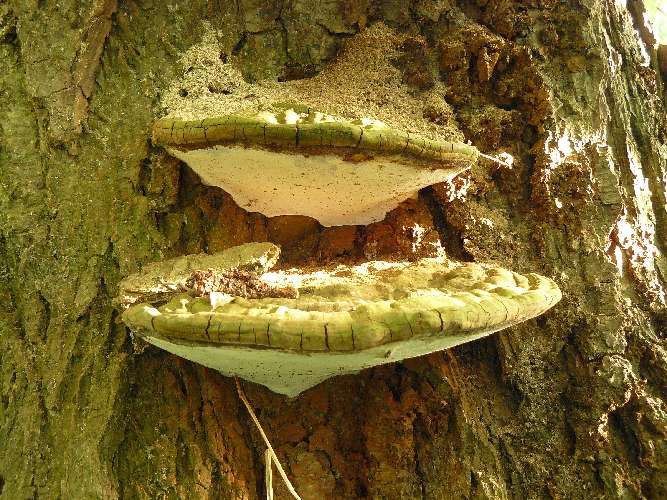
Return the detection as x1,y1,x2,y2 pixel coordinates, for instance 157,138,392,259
0,0,667,499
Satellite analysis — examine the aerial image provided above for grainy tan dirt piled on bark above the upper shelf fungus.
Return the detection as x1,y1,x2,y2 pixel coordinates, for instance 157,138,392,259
162,23,463,141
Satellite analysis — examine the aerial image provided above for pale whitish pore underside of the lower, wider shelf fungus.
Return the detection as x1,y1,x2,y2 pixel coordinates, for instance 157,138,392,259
143,326,490,397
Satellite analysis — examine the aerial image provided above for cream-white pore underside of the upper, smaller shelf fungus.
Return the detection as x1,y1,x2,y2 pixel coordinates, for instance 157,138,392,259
168,146,458,226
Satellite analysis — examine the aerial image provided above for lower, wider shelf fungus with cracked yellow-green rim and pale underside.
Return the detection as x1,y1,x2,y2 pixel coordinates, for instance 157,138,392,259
123,244,561,397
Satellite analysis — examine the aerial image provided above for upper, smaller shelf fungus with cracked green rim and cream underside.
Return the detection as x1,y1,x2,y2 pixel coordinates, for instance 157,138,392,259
153,110,479,226
